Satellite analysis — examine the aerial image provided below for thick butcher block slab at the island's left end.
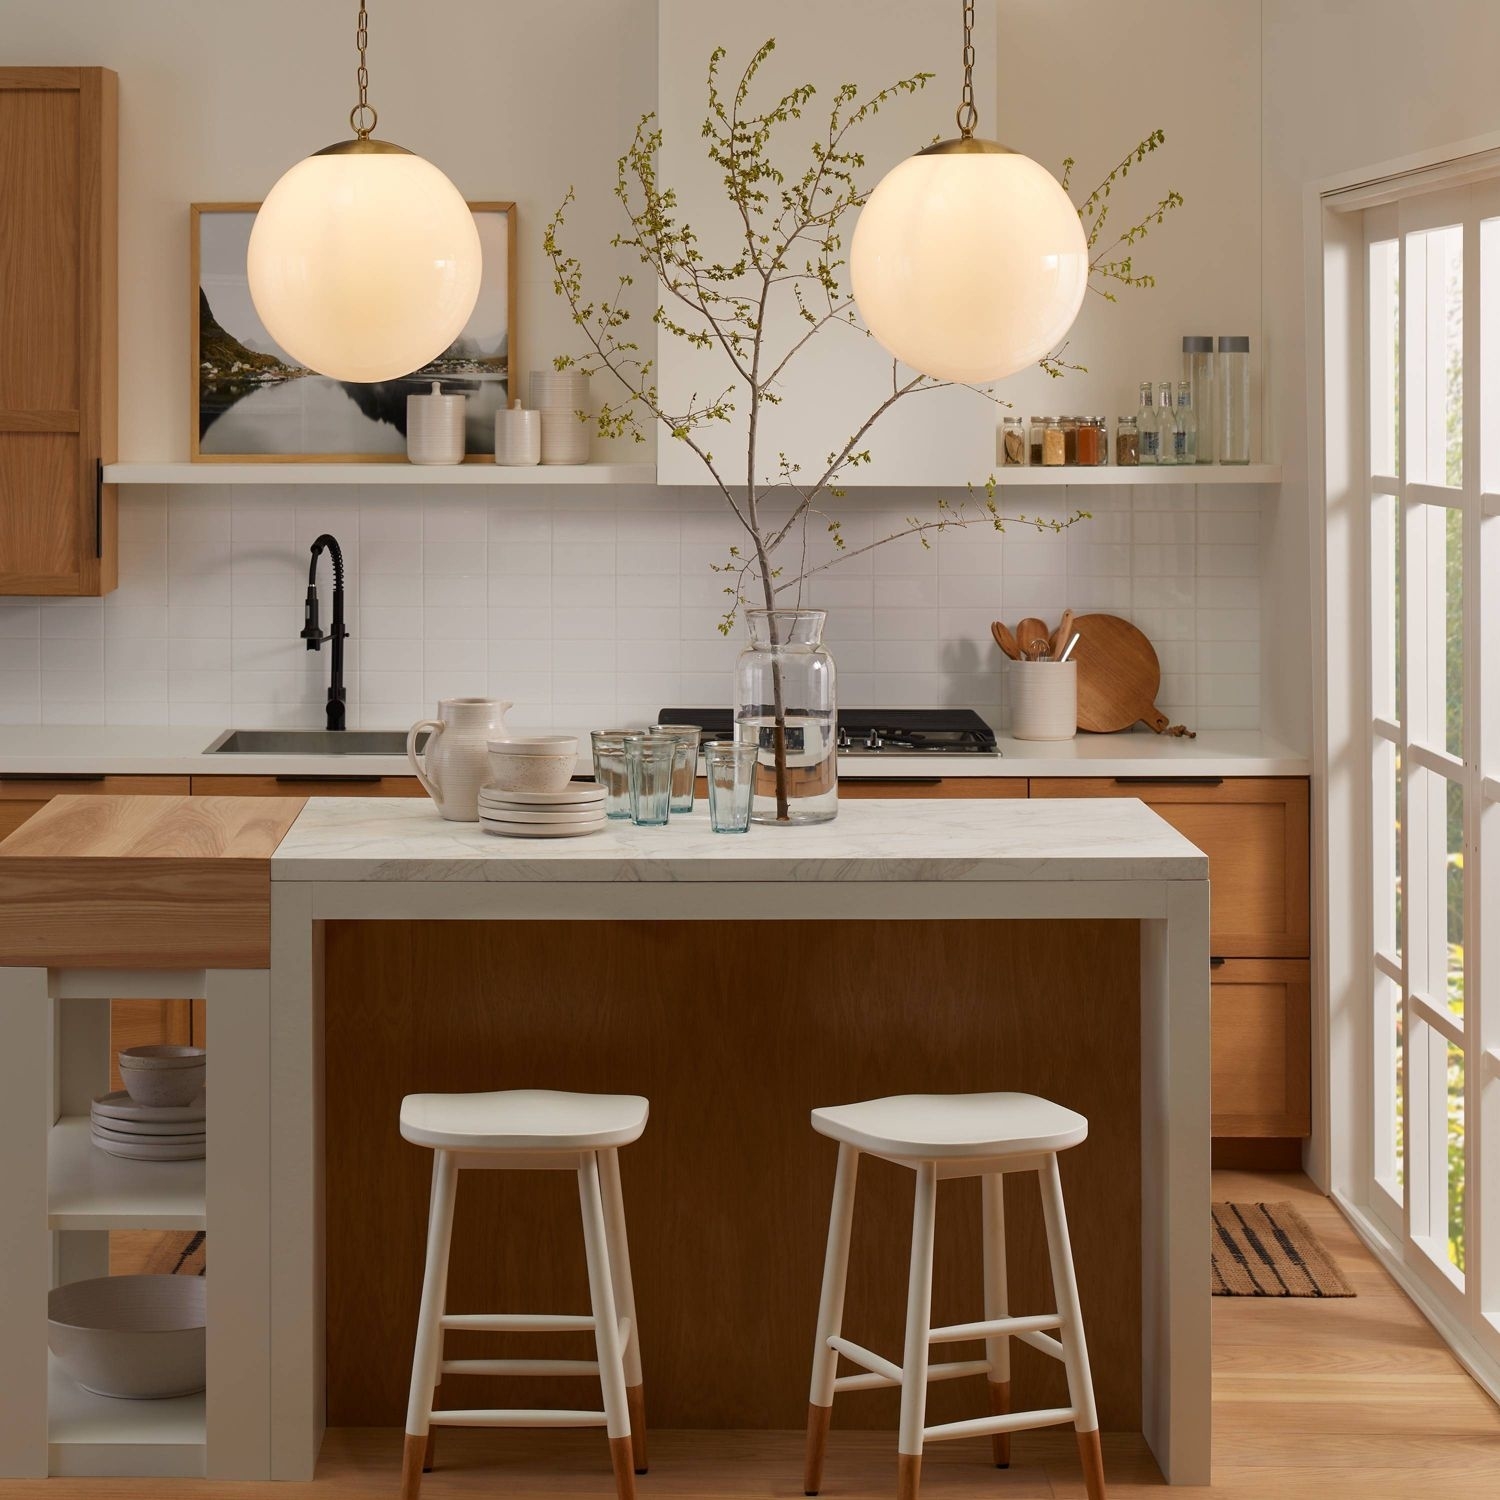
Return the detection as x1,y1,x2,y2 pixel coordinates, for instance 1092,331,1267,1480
0,795,303,969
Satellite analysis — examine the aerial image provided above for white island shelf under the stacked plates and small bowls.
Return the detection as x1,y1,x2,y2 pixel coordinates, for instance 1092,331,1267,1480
47,1116,207,1230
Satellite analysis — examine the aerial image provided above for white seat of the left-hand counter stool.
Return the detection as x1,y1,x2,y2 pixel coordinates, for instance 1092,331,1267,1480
401,1089,650,1152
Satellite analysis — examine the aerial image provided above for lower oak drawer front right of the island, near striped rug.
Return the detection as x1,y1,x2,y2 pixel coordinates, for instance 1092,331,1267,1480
1212,959,1313,1137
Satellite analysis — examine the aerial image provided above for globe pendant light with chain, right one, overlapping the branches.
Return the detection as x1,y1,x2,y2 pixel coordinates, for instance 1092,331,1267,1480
849,0,1089,384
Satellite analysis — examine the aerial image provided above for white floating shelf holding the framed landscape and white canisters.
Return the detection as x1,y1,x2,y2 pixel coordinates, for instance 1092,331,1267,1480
104,464,656,486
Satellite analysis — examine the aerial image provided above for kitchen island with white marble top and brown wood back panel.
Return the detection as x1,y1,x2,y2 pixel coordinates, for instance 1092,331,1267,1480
0,798,1211,1487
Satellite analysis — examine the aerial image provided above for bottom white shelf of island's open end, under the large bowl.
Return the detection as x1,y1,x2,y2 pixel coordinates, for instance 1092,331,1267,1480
47,1356,207,1479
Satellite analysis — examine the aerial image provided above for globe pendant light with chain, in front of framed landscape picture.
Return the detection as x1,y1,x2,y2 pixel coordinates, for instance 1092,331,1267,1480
246,0,482,381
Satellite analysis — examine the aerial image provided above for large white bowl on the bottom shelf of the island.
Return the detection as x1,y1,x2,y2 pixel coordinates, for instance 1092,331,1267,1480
47,1277,209,1401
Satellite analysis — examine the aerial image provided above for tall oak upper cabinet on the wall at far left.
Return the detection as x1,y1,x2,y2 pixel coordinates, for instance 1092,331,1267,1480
0,68,117,594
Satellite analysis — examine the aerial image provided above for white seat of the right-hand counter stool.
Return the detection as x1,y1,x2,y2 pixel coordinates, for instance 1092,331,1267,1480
813,1094,1089,1161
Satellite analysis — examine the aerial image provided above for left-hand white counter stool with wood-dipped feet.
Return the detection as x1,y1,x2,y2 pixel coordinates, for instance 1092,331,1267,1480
401,1089,648,1500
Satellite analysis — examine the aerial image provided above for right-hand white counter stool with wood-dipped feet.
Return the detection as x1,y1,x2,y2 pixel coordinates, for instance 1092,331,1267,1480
804,1094,1104,1500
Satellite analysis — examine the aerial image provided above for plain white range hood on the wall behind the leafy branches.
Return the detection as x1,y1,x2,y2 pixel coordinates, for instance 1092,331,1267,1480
654,0,998,489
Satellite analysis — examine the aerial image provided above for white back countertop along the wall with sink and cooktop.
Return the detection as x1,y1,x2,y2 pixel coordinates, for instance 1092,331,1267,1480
0,725,1310,780
